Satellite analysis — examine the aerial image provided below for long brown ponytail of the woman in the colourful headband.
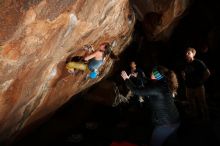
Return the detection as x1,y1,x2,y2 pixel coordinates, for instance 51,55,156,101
157,66,179,95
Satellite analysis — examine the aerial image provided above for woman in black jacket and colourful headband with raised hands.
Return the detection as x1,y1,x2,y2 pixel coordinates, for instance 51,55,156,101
121,66,180,146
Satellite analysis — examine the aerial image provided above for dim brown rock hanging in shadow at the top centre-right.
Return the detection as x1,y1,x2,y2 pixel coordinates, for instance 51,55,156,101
133,0,191,40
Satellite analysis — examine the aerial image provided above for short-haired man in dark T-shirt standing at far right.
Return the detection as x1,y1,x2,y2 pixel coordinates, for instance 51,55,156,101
182,47,210,120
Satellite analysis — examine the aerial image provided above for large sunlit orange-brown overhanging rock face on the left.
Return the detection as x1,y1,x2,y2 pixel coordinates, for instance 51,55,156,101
0,0,135,141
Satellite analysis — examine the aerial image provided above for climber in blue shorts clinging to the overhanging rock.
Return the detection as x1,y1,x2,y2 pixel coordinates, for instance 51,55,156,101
66,42,111,79
